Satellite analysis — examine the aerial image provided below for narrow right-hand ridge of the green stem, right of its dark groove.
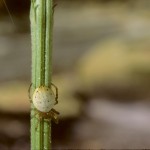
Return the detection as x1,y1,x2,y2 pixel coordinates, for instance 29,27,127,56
44,0,53,149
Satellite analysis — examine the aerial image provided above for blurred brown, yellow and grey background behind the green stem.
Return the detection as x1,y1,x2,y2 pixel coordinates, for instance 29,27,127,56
0,0,150,150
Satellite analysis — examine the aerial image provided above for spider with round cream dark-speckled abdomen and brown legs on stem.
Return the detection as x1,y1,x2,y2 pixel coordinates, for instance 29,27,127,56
28,83,59,127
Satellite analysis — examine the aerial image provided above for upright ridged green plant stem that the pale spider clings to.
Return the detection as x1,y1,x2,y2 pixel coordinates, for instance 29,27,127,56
30,0,53,150
